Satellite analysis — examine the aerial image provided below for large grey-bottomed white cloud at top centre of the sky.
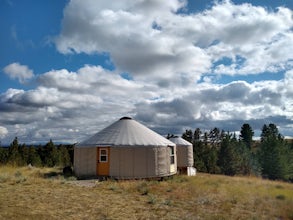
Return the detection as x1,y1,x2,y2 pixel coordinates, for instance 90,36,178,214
56,0,210,80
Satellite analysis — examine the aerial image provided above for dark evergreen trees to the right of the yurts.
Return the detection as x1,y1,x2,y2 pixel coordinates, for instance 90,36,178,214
182,124,293,182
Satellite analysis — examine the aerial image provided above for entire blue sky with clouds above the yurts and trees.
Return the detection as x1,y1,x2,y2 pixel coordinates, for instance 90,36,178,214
0,0,293,144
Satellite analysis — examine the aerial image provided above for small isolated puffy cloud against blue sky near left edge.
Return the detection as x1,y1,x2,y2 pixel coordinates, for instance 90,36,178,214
3,63,34,83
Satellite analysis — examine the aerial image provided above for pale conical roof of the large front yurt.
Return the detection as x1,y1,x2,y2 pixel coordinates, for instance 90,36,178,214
77,117,175,147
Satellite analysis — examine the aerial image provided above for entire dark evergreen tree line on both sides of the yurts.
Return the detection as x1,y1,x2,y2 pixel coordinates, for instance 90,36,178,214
0,124,293,182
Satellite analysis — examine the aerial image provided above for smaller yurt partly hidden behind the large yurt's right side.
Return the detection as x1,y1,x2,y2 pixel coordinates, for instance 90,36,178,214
169,136,196,176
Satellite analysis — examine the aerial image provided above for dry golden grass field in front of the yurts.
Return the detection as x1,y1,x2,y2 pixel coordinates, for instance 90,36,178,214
0,166,293,219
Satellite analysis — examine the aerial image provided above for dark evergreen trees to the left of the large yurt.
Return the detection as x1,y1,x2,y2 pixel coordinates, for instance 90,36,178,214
0,137,73,167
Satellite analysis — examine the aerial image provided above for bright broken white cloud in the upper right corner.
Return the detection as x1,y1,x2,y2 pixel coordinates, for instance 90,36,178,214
203,3,293,75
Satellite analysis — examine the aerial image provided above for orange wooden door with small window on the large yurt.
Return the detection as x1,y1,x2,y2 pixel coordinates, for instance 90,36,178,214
97,147,110,176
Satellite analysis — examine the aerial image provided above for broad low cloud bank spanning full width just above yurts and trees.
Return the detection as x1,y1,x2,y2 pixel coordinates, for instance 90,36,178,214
0,62,293,142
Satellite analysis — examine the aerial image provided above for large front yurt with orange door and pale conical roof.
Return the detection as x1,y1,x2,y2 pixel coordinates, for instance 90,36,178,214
74,117,177,179
